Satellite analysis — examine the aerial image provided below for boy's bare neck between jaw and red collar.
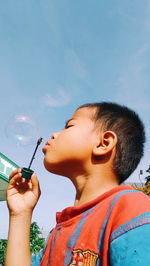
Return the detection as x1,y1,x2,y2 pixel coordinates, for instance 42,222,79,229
72,171,118,206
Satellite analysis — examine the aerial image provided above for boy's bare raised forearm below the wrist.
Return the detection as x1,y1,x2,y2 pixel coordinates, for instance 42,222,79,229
5,213,32,266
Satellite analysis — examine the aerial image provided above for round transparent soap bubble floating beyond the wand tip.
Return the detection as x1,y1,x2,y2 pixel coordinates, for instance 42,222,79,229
6,114,39,145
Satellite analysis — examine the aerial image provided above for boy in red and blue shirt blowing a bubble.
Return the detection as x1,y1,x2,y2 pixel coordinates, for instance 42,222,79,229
5,102,150,266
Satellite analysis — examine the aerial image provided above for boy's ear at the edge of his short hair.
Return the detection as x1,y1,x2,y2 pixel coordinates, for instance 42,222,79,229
93,131,117,156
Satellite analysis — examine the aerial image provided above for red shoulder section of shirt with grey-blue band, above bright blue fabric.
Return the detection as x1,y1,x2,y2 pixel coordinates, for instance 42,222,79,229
109,189,150,241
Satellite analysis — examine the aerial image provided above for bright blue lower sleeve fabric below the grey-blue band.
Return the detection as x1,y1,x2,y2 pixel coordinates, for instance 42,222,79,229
109,223,150,266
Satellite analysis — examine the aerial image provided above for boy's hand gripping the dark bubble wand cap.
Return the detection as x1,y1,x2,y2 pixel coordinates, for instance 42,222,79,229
7,169,41,216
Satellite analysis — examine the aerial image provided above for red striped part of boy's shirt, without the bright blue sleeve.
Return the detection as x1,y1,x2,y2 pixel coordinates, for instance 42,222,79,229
40,185,150,266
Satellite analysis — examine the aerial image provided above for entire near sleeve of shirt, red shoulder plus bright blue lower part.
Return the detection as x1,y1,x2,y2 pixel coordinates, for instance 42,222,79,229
109,190,150,266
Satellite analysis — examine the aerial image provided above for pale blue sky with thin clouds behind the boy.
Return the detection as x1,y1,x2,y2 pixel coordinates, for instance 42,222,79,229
0,0,150,238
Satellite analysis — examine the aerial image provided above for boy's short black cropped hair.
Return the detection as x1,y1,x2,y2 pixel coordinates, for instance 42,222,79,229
78,102,145,183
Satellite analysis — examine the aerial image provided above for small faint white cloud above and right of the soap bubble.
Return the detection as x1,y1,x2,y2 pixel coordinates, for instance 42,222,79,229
42,86,70,107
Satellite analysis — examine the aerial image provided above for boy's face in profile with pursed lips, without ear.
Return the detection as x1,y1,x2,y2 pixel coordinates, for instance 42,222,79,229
43,107,97,177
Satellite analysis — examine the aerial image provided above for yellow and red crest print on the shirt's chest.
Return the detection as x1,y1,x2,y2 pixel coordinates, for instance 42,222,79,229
69,249,98,266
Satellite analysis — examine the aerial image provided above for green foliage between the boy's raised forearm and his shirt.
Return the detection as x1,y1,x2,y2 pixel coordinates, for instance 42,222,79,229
30,222,45,254
